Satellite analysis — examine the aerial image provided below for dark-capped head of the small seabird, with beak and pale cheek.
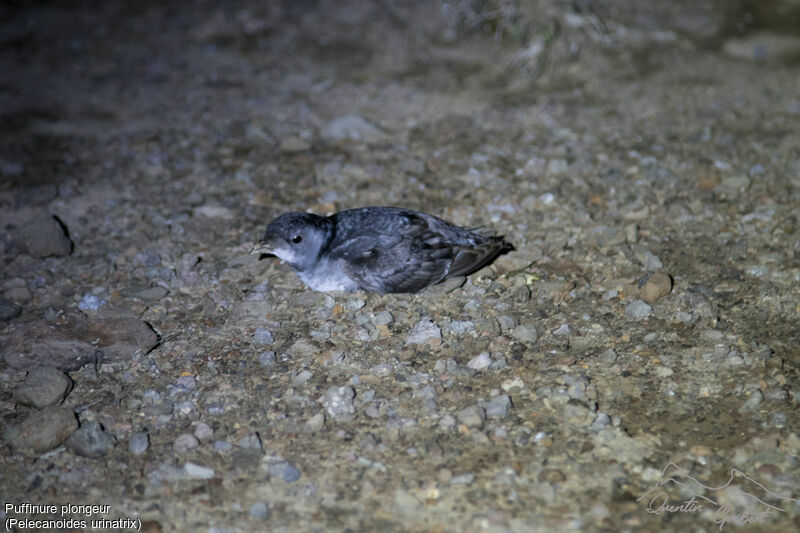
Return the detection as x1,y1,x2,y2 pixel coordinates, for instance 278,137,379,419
250,213,332,270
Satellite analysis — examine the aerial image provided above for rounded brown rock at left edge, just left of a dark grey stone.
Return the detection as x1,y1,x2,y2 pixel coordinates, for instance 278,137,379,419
3,405,78,453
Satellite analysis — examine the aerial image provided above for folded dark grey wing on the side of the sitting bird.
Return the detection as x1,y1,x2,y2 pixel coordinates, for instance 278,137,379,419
344,217,455,293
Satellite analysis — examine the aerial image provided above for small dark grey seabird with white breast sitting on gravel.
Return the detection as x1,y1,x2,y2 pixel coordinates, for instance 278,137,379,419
250,207,514,294
